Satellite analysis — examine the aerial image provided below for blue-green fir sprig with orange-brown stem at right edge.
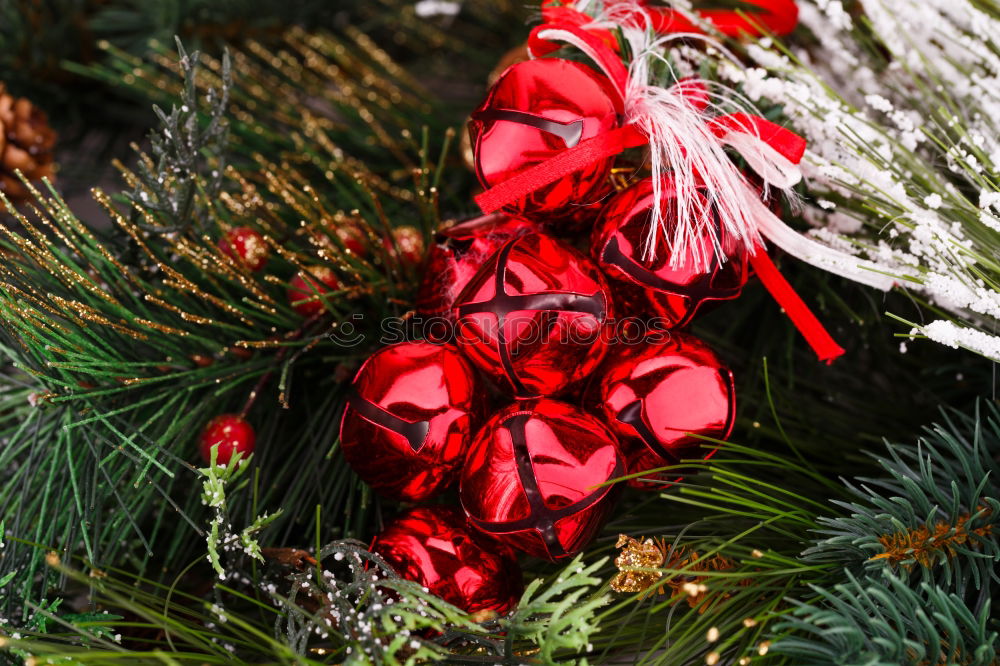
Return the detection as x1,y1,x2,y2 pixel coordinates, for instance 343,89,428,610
804,403,1000,608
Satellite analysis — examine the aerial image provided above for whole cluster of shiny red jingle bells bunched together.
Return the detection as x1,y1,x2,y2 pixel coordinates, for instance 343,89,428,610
340,49,747,613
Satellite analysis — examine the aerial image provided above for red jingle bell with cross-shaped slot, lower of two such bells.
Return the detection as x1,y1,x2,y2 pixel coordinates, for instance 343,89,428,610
461,398,625,560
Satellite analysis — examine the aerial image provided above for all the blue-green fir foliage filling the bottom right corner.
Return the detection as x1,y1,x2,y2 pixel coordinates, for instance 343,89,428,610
775,403,1000,666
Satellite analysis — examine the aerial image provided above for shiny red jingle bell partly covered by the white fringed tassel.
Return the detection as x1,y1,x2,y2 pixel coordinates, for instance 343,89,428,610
592,178,748,327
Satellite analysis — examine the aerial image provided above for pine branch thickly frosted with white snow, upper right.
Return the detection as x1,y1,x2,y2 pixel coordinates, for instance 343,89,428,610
725,0,1000,361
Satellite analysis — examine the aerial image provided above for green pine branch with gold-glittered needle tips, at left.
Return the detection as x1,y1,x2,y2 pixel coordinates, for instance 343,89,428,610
0,31,446,617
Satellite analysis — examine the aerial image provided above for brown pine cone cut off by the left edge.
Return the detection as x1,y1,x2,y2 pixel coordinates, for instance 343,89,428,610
0,82,56,203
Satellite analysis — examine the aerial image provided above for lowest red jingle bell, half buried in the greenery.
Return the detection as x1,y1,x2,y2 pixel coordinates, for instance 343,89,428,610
371,506,523,614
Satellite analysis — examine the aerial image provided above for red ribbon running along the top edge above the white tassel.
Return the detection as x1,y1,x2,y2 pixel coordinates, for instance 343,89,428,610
542,0,799,38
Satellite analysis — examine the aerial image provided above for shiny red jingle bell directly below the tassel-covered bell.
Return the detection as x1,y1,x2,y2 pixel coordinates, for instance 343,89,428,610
586,332,736,487
